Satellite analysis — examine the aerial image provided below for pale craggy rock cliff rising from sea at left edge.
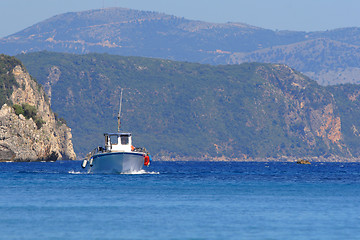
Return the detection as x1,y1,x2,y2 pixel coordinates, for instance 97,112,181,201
0,55,76,161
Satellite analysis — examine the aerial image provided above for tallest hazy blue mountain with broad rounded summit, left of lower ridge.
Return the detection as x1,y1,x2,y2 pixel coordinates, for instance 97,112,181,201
0,8,304,59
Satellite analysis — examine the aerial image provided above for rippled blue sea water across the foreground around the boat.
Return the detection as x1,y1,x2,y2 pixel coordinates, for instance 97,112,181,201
0,161,360,240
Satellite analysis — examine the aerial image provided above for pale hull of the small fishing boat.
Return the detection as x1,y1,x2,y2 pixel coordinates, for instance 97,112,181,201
90,152,144,173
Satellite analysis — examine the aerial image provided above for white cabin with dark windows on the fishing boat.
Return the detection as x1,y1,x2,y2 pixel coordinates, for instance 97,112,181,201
104,133,132,152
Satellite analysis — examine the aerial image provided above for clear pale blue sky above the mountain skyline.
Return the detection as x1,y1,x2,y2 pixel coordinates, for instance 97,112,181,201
0,0,360,37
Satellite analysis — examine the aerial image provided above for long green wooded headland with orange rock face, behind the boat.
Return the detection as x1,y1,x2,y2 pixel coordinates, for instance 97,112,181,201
18,52,359,158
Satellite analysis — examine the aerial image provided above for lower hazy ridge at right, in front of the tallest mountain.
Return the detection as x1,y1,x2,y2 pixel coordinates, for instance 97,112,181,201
228,38,360,85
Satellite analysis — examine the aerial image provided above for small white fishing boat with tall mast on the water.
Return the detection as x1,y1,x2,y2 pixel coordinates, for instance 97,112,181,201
82,90,151,173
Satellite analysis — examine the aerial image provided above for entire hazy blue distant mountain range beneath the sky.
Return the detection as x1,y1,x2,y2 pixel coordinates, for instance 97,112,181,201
0,8,360,85
